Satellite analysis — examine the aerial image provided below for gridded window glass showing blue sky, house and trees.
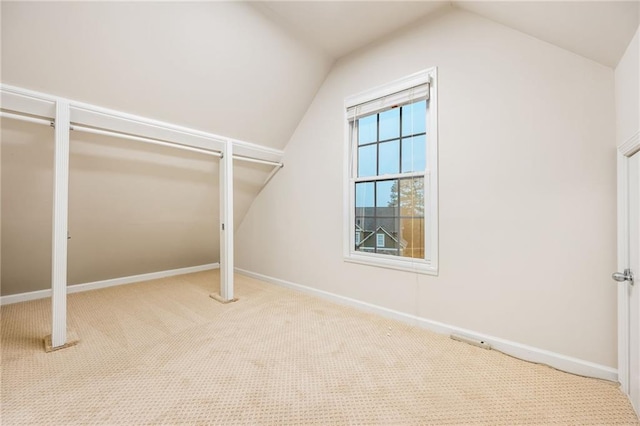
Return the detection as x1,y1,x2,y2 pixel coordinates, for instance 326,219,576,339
354,100,427,258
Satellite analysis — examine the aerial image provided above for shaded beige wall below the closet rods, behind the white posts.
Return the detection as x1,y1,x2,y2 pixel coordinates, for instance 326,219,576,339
1,120,228,295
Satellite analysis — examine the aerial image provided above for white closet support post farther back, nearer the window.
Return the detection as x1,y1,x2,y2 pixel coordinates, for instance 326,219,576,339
211,140,238,303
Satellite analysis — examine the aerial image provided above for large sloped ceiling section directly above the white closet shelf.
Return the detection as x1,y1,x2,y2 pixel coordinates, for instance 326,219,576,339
0,1,332,148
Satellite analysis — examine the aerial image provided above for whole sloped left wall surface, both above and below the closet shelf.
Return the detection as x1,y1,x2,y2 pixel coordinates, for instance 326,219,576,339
0,2,304,295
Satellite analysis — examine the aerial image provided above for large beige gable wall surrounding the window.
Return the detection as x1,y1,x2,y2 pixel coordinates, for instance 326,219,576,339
236,11,616,366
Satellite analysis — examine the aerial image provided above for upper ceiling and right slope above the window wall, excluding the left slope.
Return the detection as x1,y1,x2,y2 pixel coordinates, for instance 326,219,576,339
252,1,640,67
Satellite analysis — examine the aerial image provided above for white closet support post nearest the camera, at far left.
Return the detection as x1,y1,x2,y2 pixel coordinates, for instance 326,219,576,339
45,101,70,350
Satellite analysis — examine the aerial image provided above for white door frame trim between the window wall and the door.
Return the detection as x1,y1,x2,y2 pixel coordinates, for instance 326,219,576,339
617,131,640,395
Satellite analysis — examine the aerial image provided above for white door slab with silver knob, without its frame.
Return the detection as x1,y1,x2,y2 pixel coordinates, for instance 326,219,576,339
620,152,640,414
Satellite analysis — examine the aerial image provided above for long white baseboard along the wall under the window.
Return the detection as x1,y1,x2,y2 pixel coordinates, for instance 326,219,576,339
235,268,618,382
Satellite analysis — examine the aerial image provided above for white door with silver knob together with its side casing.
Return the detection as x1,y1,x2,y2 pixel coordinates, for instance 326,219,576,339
613,152,640,415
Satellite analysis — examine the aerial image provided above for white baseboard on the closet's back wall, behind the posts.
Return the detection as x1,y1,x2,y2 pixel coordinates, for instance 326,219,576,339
0,263,220,306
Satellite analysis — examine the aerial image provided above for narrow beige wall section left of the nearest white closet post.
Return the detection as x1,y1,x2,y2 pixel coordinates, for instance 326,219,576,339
0,119,53,295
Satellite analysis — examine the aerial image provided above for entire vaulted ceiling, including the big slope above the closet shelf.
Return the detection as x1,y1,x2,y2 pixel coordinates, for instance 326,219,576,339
0,1,639,155
